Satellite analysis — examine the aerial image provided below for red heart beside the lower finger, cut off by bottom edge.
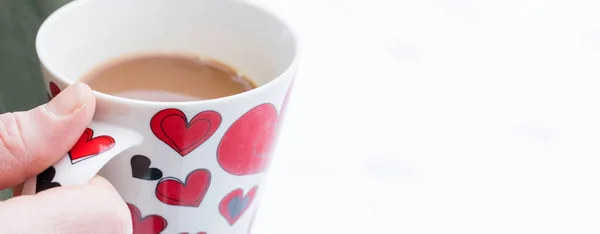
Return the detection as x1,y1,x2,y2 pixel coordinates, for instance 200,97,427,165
127,203,167,234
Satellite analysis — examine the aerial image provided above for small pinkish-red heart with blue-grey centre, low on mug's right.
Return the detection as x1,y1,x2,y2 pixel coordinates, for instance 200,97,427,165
219,186,258,225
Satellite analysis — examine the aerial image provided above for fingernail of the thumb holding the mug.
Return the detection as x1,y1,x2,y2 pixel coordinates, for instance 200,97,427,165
46,82,86,116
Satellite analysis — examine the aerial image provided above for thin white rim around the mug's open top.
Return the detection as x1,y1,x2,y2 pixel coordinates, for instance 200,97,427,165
35,0,301,106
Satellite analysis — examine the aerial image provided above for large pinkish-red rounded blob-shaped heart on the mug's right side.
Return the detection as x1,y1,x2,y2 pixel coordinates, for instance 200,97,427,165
217,103,278,176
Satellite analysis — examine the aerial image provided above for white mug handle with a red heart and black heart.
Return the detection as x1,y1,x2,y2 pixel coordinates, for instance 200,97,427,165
22,121,143,195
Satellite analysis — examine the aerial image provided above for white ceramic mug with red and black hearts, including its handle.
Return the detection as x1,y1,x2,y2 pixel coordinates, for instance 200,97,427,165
23,0,298,234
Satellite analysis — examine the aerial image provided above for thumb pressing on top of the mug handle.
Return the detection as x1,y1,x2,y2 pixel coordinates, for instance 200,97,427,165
0,83,96,189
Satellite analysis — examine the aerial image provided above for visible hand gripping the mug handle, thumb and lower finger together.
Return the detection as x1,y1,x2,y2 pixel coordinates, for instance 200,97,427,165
0,83,133,234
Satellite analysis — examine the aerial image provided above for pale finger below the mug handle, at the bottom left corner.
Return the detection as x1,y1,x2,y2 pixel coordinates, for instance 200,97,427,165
0,177,133,234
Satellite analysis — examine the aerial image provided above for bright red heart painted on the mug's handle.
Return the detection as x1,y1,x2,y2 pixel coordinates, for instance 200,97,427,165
69,128,115,164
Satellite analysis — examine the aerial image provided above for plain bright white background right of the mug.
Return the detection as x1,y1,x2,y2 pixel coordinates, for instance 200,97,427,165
254,0,600,234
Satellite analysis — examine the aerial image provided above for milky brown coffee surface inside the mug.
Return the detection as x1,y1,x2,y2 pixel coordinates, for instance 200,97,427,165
80,54,256,102
